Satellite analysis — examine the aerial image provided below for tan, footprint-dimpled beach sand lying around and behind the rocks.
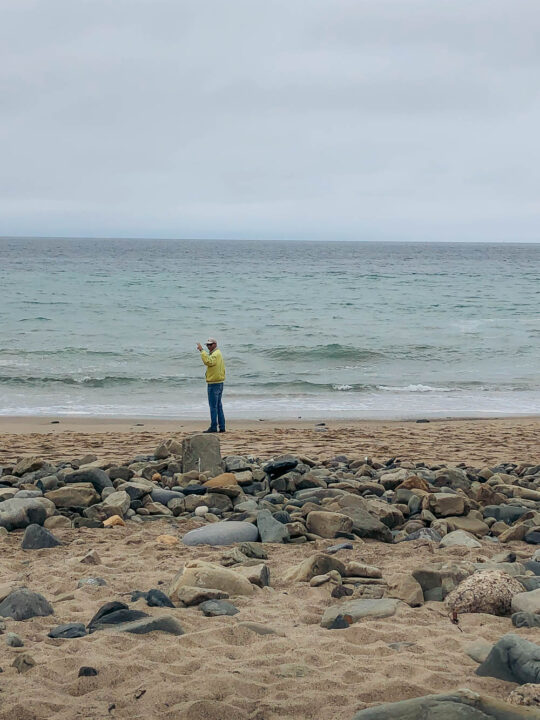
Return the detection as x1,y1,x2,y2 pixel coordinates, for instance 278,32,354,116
0,419,540,720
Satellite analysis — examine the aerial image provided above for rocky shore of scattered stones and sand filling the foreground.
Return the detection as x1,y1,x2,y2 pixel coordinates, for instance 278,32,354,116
0,435,540,720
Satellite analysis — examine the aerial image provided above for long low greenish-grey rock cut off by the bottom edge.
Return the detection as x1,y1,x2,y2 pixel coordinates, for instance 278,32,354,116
353,689,534,720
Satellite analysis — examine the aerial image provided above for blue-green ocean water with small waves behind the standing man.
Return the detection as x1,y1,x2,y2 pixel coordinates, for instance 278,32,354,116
0,239,540,419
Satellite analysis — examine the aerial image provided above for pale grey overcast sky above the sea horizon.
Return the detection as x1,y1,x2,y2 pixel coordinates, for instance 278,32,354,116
0,0,540,242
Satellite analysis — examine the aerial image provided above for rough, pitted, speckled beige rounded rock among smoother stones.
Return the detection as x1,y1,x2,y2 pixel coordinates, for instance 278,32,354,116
446,570,523,615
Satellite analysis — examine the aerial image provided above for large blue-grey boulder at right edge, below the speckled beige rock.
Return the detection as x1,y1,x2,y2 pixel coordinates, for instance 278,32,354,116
476,633,540,685
